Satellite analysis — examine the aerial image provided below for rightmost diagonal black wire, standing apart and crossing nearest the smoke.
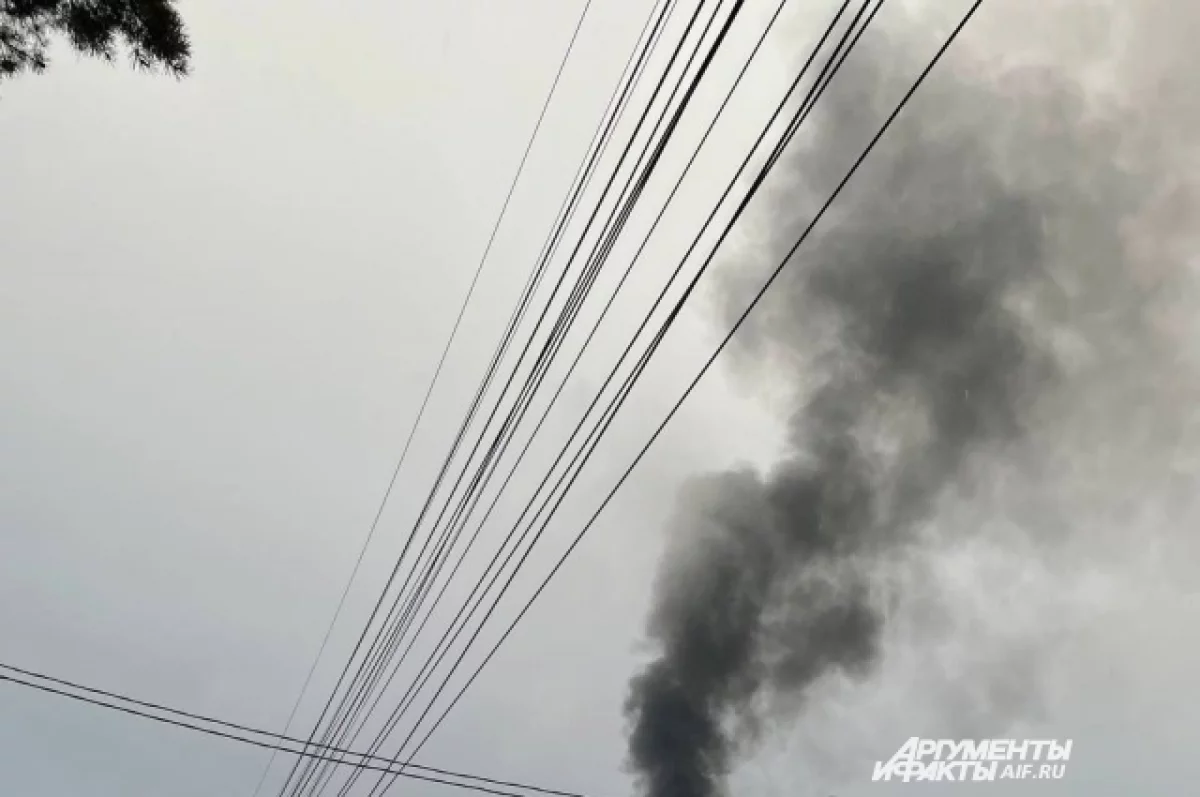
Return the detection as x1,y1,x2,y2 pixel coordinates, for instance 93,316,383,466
389,0,983,787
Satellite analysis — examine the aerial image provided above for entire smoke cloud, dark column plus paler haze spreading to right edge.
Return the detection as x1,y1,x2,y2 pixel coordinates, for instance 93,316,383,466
626,4,1200,797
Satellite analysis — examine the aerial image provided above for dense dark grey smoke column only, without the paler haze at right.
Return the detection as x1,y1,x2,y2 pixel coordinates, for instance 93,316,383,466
626,4,1180,797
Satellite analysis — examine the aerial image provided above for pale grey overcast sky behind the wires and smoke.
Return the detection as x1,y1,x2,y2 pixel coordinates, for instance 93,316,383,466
0,0,1200,797
